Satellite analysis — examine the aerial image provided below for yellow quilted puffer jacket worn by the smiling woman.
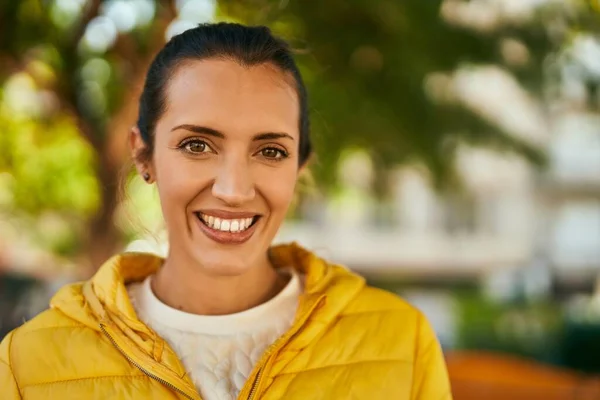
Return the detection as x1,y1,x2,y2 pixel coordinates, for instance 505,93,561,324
0,245,451,400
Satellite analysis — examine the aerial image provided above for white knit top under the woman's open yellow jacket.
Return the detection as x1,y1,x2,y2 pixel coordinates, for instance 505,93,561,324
127,269,302,400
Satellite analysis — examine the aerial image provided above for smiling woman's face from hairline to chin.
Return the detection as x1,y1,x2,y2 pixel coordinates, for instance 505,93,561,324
135,60,300,275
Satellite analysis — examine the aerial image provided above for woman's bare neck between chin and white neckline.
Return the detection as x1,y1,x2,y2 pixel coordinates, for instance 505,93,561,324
152,250,287,315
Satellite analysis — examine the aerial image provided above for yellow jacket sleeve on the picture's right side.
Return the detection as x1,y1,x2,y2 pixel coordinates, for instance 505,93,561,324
410,313,452,400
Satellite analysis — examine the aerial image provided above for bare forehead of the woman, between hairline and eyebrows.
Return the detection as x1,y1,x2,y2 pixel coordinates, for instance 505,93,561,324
159,59,300,137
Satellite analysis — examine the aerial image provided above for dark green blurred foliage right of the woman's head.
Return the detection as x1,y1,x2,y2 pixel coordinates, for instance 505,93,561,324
220,0,554,187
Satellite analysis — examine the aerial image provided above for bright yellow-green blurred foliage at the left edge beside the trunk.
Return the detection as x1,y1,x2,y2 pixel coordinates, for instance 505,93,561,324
0,90,100,217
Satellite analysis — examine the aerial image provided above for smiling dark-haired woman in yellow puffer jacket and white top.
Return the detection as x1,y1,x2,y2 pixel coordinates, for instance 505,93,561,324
0,24,451,400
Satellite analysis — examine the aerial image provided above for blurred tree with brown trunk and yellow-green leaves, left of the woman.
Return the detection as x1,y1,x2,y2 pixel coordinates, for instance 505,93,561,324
0,0,176,272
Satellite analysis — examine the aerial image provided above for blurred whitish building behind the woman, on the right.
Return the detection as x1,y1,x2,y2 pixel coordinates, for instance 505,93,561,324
278,89,600,292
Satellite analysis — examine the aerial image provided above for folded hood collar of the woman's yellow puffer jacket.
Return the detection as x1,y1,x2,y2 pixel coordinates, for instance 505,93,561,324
50,243,365,399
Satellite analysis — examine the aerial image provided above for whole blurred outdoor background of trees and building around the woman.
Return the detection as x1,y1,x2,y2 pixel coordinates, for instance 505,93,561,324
0,0,600,399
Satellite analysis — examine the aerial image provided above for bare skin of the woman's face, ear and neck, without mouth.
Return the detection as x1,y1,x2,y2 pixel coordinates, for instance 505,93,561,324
130,59,300,315
